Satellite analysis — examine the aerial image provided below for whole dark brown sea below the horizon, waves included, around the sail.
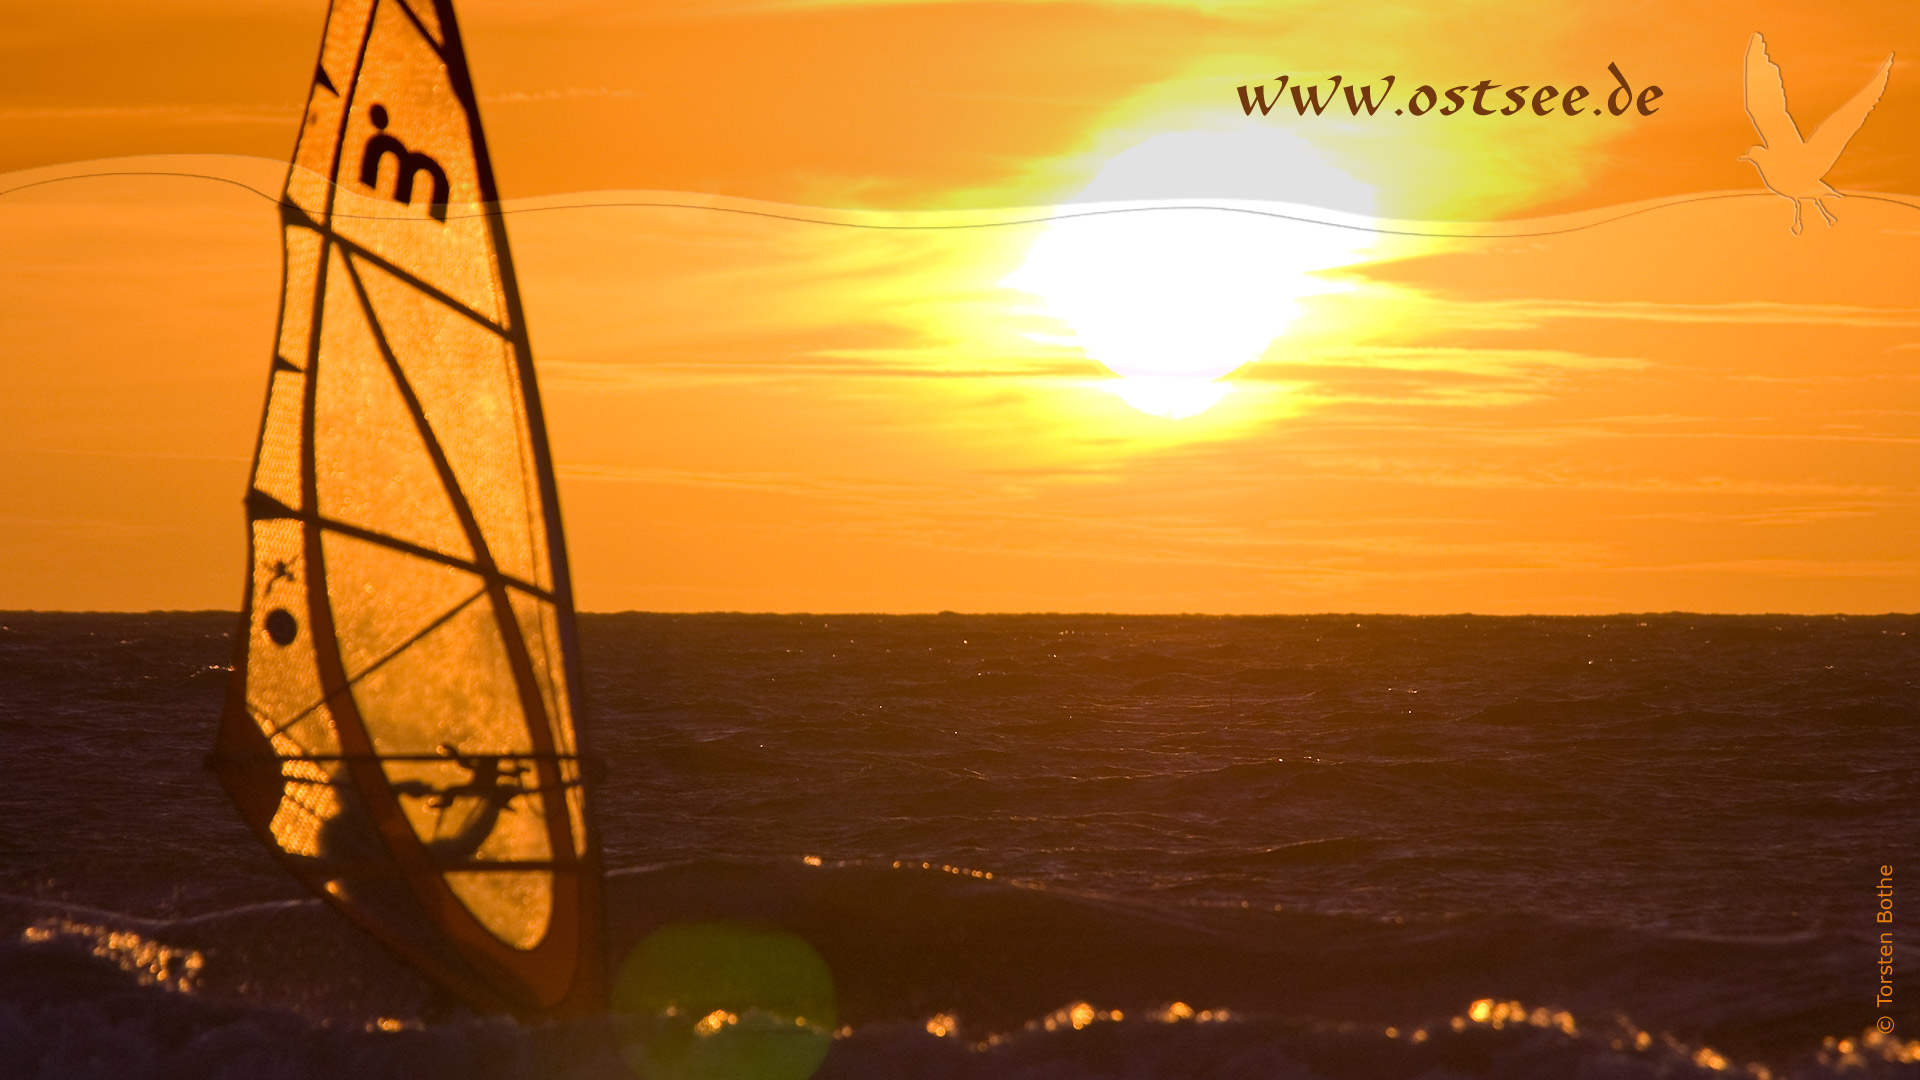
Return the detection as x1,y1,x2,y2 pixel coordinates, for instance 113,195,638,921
0,613,1920,1080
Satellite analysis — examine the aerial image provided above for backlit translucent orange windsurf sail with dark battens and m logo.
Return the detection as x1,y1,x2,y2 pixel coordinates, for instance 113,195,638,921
211,0,605,1015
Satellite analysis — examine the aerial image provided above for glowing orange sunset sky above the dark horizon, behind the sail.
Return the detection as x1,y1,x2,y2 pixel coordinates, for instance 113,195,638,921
0,0,1920,613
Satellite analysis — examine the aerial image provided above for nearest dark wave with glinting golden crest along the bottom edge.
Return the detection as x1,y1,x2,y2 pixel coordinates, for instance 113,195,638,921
0,914,1920,1080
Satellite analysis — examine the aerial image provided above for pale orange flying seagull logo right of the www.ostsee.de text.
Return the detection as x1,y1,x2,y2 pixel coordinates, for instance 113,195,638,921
1740,33,1893,236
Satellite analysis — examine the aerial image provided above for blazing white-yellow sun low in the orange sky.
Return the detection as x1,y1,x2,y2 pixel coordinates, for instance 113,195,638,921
1000,127,1375,419
